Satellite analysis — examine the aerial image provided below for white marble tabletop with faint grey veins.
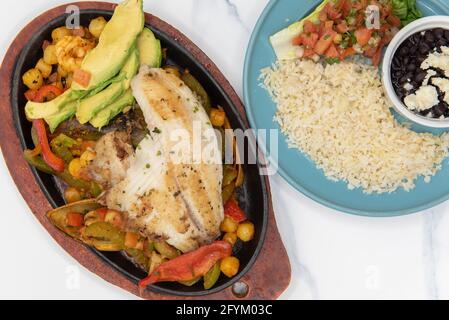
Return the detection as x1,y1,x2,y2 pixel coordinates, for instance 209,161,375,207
0,0,449,299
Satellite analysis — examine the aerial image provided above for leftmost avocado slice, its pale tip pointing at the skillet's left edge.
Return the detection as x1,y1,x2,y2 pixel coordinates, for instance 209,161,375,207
25,89,86,120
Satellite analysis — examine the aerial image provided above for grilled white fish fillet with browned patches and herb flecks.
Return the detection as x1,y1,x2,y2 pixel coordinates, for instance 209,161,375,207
103,67,223,252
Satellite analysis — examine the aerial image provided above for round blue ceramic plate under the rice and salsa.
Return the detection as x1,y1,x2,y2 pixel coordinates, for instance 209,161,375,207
243,0,449,217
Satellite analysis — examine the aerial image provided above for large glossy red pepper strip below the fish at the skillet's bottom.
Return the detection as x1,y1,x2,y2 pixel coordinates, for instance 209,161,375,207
139,241,232,290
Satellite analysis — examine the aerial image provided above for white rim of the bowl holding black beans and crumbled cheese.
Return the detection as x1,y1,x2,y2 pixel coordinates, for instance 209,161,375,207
382,16,449,128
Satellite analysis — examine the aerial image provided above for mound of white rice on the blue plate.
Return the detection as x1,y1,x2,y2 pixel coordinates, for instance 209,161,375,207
262,60,449,193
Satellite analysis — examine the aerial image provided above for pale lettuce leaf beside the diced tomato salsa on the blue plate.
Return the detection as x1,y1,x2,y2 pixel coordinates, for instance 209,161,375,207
270,0,332,60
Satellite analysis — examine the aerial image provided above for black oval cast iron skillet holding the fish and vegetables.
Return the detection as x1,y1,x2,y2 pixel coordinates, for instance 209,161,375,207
11,9,269,296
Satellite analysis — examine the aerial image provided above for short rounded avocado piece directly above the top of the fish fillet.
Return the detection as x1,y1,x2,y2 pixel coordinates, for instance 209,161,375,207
137,28,162,68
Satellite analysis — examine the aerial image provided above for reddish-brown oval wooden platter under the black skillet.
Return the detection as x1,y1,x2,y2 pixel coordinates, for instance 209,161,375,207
0,1,291,300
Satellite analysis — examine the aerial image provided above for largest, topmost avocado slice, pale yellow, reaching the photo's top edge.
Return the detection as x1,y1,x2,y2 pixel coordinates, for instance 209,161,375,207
72,0,145,91
